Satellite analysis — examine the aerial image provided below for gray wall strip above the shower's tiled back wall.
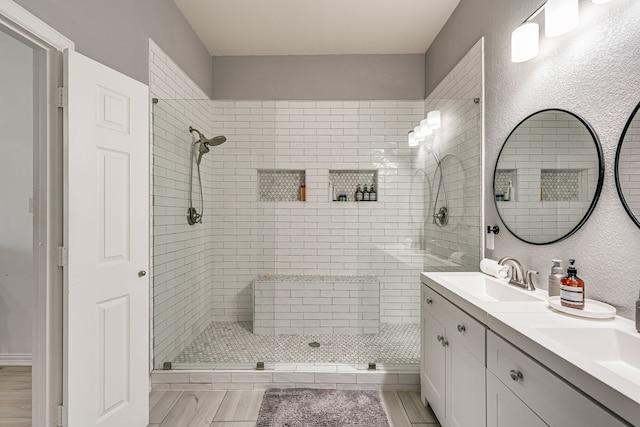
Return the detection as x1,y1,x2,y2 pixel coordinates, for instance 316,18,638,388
213,54,424,100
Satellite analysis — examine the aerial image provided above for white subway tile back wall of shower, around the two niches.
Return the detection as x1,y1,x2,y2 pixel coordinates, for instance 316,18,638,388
211,100,424,323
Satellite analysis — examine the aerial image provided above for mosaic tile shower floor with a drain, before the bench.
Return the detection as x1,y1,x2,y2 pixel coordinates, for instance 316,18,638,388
173,322,420,366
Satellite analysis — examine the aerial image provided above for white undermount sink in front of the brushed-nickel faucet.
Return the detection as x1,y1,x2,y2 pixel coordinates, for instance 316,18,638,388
432,273,541,302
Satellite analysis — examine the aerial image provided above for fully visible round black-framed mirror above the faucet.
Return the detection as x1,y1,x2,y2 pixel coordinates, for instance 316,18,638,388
493,108,604,245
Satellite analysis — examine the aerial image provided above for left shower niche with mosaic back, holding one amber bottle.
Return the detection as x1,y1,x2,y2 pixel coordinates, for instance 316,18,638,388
258,169,306,202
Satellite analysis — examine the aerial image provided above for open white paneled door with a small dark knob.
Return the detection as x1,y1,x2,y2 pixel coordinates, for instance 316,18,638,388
64,51,149,427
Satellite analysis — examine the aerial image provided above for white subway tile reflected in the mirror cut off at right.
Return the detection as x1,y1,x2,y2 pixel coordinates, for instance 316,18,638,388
618,113,640,216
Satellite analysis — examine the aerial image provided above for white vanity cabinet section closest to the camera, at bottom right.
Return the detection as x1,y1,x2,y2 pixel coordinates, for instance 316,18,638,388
487,331,628,427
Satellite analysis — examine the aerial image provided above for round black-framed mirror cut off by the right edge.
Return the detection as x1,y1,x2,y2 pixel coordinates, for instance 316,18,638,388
615,103,640,227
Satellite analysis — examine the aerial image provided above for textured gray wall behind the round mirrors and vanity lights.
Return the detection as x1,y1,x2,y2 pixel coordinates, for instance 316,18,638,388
426,0,640,318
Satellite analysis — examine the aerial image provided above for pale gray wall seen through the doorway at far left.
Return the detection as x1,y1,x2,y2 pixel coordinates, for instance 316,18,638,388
0,32,34,358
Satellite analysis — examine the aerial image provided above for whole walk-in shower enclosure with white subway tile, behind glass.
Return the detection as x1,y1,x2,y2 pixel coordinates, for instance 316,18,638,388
152,40,481,369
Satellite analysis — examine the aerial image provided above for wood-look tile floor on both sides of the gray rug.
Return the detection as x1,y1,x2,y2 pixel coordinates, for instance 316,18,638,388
149,390,440,427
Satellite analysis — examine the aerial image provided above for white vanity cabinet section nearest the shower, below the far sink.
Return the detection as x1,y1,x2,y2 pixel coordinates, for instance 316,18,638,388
420,284,486,427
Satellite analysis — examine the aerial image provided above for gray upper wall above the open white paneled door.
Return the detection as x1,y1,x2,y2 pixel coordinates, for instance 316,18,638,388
16,0,212,95
